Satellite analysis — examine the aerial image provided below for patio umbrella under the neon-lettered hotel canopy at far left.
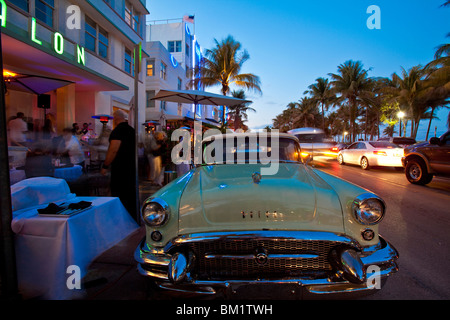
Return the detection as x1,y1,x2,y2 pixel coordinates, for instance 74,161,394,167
4,72,73,95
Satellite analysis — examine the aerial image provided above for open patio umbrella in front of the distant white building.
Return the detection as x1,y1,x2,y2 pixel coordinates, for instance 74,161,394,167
152,89,251,120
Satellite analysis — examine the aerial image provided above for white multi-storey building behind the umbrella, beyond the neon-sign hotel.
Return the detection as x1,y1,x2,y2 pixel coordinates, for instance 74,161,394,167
145,18,220,125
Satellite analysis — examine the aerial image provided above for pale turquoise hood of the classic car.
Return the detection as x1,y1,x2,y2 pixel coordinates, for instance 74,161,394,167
179,163,344,234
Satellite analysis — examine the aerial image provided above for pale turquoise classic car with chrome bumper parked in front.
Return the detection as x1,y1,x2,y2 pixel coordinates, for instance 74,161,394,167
135,133,398,298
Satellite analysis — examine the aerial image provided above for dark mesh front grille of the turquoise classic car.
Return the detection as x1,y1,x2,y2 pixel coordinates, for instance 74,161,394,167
189,239,337,279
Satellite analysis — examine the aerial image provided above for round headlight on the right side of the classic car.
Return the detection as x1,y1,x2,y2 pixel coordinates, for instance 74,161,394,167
352,193,386,225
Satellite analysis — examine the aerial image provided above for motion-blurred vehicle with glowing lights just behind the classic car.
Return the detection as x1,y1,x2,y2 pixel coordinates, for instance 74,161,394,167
287,127,338,159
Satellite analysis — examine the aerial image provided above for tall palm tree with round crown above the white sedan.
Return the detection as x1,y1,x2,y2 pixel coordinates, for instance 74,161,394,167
329,60,371,141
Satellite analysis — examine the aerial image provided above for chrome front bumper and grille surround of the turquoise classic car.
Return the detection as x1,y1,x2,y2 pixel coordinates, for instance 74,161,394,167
135,231,399,295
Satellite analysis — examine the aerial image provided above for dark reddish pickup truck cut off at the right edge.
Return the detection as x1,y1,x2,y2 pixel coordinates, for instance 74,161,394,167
402,130,450,185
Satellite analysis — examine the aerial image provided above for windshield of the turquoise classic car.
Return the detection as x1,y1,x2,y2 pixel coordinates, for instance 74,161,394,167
203,136,301,164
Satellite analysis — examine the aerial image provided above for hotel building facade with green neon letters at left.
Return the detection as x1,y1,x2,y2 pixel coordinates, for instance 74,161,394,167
1,0,149,134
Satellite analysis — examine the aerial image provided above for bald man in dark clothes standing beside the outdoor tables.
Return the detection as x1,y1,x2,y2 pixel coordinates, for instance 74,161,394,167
101,110,138,221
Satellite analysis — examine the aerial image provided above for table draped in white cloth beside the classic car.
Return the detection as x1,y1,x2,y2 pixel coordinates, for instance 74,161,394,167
11,177,138,300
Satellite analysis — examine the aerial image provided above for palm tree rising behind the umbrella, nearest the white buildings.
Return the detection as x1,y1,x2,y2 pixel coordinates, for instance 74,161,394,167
190,35,261,121
